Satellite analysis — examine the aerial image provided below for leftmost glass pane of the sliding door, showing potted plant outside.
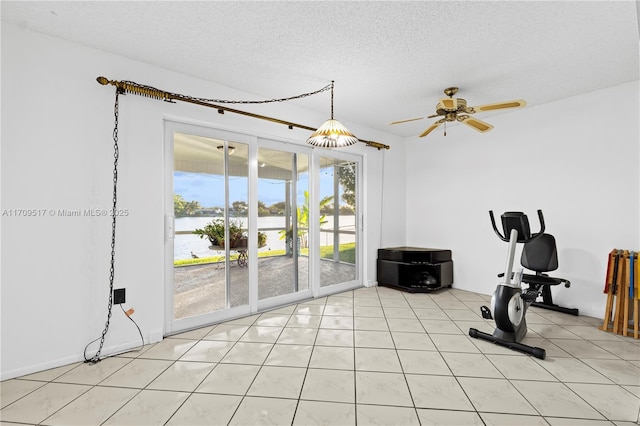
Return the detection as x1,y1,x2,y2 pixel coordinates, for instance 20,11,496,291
173,132,249,320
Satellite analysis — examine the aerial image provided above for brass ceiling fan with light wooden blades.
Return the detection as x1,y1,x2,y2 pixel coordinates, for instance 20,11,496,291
389,87,527,138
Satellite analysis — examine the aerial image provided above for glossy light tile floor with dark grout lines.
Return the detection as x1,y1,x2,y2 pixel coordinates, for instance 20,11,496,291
0,287,640,426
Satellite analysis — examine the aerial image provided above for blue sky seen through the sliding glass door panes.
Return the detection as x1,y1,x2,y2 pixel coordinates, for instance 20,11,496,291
173,171,343,207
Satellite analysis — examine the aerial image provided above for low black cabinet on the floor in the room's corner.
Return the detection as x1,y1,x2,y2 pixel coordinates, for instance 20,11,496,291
378,247,453,293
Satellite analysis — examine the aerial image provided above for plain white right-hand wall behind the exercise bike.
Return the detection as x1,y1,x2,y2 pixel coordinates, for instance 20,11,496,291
406,81,640,318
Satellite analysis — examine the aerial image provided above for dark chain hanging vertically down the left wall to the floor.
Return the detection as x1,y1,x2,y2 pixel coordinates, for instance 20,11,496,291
84,89,120,364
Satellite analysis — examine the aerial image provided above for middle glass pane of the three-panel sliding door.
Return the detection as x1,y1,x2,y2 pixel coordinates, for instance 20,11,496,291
258,147,309,300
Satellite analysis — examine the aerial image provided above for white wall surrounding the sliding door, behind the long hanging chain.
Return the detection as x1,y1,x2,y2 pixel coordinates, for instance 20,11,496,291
0,23,405,379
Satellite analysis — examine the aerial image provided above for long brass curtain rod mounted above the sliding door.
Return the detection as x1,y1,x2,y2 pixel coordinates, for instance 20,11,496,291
96,77,389,151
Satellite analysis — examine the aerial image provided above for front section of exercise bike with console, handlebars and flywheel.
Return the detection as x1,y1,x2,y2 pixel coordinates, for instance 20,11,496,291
469,210,546,359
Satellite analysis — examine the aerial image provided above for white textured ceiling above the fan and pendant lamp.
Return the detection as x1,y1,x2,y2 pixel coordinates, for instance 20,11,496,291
1,1,639,139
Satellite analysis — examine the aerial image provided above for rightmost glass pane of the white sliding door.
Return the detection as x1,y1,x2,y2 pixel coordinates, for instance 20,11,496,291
319,157,358,287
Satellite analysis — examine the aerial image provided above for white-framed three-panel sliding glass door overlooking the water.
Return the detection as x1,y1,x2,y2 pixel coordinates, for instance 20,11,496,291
165,120,361,334
